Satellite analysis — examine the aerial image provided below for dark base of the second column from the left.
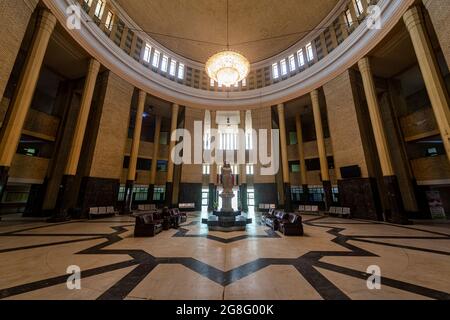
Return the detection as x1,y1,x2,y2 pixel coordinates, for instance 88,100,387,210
47,175,75,223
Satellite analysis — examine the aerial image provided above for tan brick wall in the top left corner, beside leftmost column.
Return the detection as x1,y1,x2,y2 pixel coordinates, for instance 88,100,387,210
0,0,38,99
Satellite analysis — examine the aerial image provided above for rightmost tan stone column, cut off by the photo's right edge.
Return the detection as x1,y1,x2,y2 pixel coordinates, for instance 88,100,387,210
403,6,450,160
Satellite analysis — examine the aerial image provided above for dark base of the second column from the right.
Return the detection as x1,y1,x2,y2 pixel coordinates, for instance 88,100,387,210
383,176,409,224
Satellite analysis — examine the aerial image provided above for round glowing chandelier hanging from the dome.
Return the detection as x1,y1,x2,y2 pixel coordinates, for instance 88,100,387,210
206,50,250,87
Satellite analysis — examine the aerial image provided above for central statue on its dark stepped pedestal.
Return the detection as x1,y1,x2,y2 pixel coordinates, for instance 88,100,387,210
203,162,252,232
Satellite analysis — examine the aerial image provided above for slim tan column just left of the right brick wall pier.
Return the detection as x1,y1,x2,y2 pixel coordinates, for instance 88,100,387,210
311,90,333,210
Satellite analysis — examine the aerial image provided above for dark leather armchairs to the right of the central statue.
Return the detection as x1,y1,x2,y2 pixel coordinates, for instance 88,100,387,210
262,209,303,236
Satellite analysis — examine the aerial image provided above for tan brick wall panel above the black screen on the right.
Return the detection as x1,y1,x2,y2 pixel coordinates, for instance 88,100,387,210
323,71,369,179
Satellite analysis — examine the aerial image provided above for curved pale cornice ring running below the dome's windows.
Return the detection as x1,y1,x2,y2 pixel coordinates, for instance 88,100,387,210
43,0,414,110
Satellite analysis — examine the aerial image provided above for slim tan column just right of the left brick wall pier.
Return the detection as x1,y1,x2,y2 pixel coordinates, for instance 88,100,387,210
124,90,147,213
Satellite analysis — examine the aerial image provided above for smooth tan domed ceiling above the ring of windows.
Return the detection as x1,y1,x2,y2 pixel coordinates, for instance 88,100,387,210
116,0,339,63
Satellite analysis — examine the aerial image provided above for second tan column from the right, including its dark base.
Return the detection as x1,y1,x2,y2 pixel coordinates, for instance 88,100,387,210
358,57,407,223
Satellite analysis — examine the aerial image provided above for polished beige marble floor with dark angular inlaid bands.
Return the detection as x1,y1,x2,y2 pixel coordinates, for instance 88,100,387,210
0,213,450,300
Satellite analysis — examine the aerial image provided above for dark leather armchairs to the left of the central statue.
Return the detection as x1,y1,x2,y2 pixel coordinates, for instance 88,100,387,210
134,208,187,237
